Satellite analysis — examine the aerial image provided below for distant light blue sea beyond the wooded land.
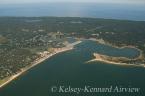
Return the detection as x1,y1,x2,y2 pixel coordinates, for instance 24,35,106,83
0,3,145,21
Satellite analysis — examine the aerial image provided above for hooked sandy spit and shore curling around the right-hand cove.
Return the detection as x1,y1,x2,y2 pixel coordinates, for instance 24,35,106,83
86,38,145,67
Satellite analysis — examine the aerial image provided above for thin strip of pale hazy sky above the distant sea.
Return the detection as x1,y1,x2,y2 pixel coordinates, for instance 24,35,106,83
0,0,145,4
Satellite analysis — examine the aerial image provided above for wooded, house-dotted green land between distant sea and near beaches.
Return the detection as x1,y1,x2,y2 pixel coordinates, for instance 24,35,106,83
0,17,145,79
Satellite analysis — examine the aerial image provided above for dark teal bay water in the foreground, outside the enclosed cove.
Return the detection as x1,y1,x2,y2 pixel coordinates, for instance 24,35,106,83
0,41,145,96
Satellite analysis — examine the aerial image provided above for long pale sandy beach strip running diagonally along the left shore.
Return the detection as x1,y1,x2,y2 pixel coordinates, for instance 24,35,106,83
0,41,82,88
